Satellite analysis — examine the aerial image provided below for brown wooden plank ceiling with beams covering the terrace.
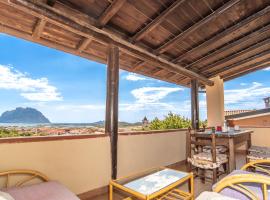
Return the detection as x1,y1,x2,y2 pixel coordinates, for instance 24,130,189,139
0,0,270,86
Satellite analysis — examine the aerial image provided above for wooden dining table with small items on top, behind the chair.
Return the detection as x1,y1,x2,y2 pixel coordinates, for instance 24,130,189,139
194,130,253,172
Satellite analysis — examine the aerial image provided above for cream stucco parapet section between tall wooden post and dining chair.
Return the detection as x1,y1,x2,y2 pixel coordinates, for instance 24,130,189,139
118,131,186,176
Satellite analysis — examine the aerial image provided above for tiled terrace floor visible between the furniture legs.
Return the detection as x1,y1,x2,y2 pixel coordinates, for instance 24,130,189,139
89,155,245,200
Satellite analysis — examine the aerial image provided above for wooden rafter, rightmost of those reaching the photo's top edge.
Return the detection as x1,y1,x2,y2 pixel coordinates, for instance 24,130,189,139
156,0,240,54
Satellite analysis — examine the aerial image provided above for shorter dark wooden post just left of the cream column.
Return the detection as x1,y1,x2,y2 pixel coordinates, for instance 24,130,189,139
191,79,200,130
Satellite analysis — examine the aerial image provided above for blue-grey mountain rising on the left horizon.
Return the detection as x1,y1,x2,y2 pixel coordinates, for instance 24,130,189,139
0,108,50,124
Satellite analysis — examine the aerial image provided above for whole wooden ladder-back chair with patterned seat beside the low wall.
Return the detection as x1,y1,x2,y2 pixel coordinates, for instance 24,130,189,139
187,129,228,183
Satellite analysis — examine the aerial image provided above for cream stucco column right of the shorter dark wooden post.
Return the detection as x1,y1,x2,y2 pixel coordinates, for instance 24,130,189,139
206,76,225,127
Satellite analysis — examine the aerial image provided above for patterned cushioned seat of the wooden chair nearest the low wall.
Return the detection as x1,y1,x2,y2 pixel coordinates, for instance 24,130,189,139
188,152,228,169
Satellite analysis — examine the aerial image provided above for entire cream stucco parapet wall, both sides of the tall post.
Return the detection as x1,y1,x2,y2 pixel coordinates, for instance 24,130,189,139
0,131,185,194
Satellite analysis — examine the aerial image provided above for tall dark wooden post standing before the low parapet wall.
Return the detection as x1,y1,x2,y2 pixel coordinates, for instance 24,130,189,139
105,45,119,179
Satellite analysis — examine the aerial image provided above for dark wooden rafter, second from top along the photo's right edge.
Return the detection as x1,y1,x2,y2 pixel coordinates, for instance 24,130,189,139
186,24,270,69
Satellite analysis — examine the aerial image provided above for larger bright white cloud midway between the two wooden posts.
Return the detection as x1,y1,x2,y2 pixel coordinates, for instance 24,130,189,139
131,87,184,104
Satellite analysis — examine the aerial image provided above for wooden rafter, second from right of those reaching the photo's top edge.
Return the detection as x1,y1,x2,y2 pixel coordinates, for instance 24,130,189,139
132,0,186,42
